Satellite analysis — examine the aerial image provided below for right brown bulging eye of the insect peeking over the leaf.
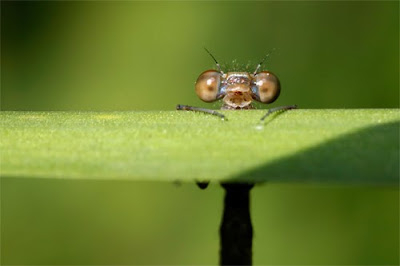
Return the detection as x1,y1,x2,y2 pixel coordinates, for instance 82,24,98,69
251,71,281,103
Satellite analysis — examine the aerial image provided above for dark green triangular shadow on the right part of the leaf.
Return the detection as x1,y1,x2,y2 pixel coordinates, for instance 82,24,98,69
229,121,399,185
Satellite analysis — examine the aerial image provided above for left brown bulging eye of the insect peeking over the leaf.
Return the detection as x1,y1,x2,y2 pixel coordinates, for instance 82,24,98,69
195,70,221,102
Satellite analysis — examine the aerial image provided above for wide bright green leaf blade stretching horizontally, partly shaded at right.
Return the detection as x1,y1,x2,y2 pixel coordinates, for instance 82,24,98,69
0,109,400,184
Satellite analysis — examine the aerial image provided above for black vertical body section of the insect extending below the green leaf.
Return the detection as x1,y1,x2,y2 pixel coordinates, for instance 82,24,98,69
220,183,254,265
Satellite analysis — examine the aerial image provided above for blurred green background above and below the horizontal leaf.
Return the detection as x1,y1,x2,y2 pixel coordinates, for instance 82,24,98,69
1,1,399,265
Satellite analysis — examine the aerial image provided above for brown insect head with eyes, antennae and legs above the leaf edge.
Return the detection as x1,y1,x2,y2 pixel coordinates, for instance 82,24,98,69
176,49,296,120
